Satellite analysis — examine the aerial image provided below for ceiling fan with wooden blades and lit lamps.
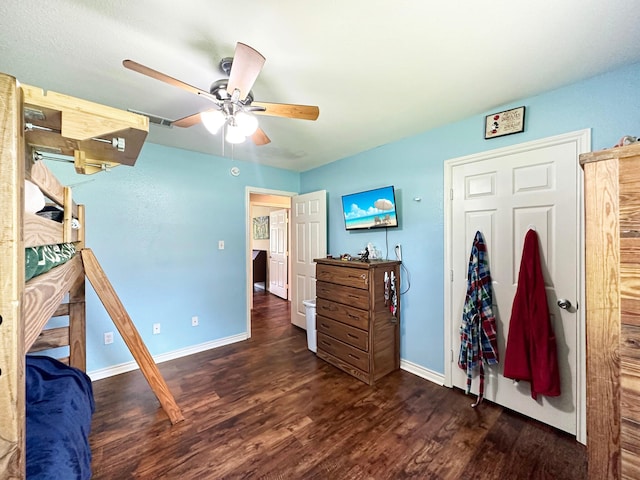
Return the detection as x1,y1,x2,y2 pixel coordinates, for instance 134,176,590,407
122,42,320,145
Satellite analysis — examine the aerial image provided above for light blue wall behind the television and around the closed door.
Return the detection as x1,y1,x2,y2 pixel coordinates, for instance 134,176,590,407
300,64,640,373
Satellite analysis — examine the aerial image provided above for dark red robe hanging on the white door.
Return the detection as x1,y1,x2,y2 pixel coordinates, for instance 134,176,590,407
504,230,560,399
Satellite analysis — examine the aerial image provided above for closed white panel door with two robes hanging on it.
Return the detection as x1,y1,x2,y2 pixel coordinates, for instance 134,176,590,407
445,131,589,440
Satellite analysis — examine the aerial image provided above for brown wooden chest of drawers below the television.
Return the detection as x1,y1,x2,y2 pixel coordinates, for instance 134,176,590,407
315,258,400,385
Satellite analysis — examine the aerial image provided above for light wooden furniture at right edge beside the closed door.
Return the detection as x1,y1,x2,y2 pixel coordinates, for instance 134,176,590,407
580,144,640,480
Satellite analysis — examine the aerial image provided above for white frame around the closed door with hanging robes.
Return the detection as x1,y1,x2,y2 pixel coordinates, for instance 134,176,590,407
443,129,591,444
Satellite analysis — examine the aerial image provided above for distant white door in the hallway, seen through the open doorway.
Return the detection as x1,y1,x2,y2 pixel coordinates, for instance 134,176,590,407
269,209,289,300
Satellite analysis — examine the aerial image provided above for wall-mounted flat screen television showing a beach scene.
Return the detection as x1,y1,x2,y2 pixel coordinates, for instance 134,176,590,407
342,185,398,230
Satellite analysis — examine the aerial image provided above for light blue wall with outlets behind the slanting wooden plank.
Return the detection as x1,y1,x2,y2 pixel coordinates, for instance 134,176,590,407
48,144,299,372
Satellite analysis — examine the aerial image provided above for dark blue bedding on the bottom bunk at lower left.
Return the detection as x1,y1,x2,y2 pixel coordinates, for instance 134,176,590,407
26,355,95,480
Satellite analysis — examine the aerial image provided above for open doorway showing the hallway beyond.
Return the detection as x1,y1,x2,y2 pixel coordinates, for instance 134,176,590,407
245,187,296,336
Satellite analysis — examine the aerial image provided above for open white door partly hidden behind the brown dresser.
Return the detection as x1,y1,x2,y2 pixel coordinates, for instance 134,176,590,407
291,190,327,329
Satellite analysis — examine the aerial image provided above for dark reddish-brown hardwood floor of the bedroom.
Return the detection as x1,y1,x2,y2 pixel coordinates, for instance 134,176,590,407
91,291,586,480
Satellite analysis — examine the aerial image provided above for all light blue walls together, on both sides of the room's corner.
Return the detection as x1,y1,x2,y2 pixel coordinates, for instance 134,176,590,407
49,64,640,373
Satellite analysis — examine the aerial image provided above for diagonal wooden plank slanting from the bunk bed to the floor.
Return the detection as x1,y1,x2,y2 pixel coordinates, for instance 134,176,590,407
80,248,184,424
